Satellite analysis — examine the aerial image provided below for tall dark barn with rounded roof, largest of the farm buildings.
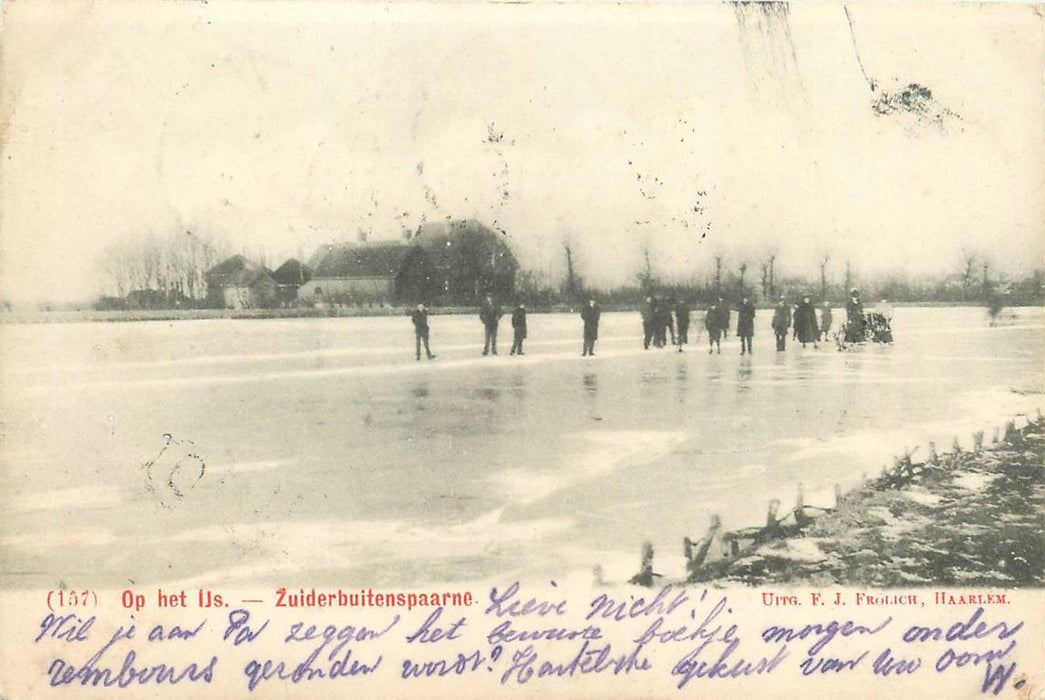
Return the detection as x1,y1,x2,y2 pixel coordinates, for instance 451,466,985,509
411,219,518,305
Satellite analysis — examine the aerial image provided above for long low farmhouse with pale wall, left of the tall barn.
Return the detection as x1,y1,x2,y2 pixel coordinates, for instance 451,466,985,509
298,242,434,304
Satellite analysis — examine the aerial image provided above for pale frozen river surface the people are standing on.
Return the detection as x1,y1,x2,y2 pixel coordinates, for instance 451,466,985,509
0,308,1045,588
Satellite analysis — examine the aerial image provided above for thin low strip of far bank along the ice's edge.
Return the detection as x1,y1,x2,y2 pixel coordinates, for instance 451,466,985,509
0,300,1015,324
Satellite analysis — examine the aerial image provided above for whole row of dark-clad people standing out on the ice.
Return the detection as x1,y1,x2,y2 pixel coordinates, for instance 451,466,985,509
411,289,892,360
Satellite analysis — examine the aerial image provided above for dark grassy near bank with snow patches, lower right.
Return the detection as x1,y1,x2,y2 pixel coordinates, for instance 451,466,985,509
677,415,1045,588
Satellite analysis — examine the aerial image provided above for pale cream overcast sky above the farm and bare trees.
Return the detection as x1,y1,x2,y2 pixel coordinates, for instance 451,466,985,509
0,2,1045,300
